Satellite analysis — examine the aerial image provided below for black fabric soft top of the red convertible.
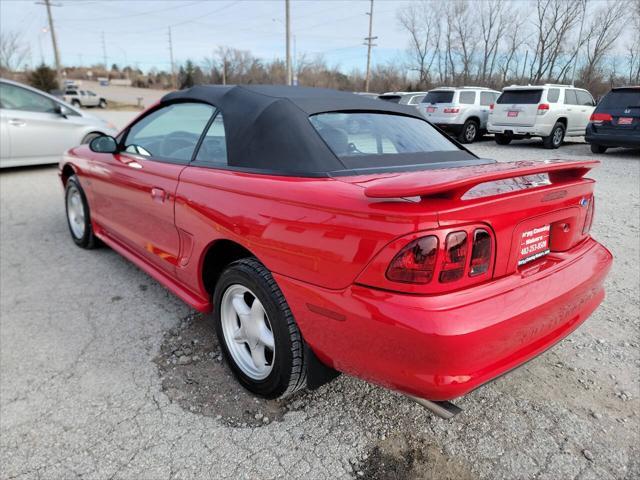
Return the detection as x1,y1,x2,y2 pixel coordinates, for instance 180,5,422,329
160,85,474,176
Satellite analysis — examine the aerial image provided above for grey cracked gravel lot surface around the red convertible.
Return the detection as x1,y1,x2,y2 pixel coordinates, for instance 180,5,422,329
0,137,640,480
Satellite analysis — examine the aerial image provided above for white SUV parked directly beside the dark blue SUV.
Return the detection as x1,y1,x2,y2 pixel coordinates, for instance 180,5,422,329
487,84,596,148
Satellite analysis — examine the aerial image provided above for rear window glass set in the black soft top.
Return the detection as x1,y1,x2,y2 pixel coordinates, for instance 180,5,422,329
309,113,474,168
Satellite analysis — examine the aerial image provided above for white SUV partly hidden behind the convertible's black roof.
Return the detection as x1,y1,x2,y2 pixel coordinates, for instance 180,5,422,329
418,87,500,143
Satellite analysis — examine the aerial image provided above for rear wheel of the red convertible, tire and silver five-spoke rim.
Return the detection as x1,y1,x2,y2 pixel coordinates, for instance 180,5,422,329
213,258,306,398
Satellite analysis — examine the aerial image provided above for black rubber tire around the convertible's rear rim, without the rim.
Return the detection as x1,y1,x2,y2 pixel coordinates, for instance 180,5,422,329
213,258,307,398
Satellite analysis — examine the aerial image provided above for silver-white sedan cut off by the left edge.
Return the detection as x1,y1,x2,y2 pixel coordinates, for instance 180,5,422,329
0,79,117,168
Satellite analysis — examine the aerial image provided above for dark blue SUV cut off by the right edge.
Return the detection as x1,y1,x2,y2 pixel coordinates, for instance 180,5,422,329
585,86,640,153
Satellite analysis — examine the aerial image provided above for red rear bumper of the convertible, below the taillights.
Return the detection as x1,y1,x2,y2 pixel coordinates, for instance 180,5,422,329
276,239,612,400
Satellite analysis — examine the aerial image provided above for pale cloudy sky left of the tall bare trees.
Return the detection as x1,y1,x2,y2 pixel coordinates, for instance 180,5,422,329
0,0,420,71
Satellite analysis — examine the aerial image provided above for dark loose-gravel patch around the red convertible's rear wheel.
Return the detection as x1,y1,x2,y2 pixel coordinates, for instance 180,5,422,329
155,314,300,427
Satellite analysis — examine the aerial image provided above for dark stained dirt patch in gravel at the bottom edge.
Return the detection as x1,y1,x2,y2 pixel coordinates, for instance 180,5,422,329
354,434,475,480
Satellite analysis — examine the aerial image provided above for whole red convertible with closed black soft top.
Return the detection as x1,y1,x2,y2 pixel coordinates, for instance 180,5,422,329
60,86,612,417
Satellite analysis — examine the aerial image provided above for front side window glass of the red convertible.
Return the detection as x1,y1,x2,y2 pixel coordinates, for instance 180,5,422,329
124,103,215,163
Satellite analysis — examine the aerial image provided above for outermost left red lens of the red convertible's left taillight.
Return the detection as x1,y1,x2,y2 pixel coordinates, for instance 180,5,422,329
387,235,438,283
